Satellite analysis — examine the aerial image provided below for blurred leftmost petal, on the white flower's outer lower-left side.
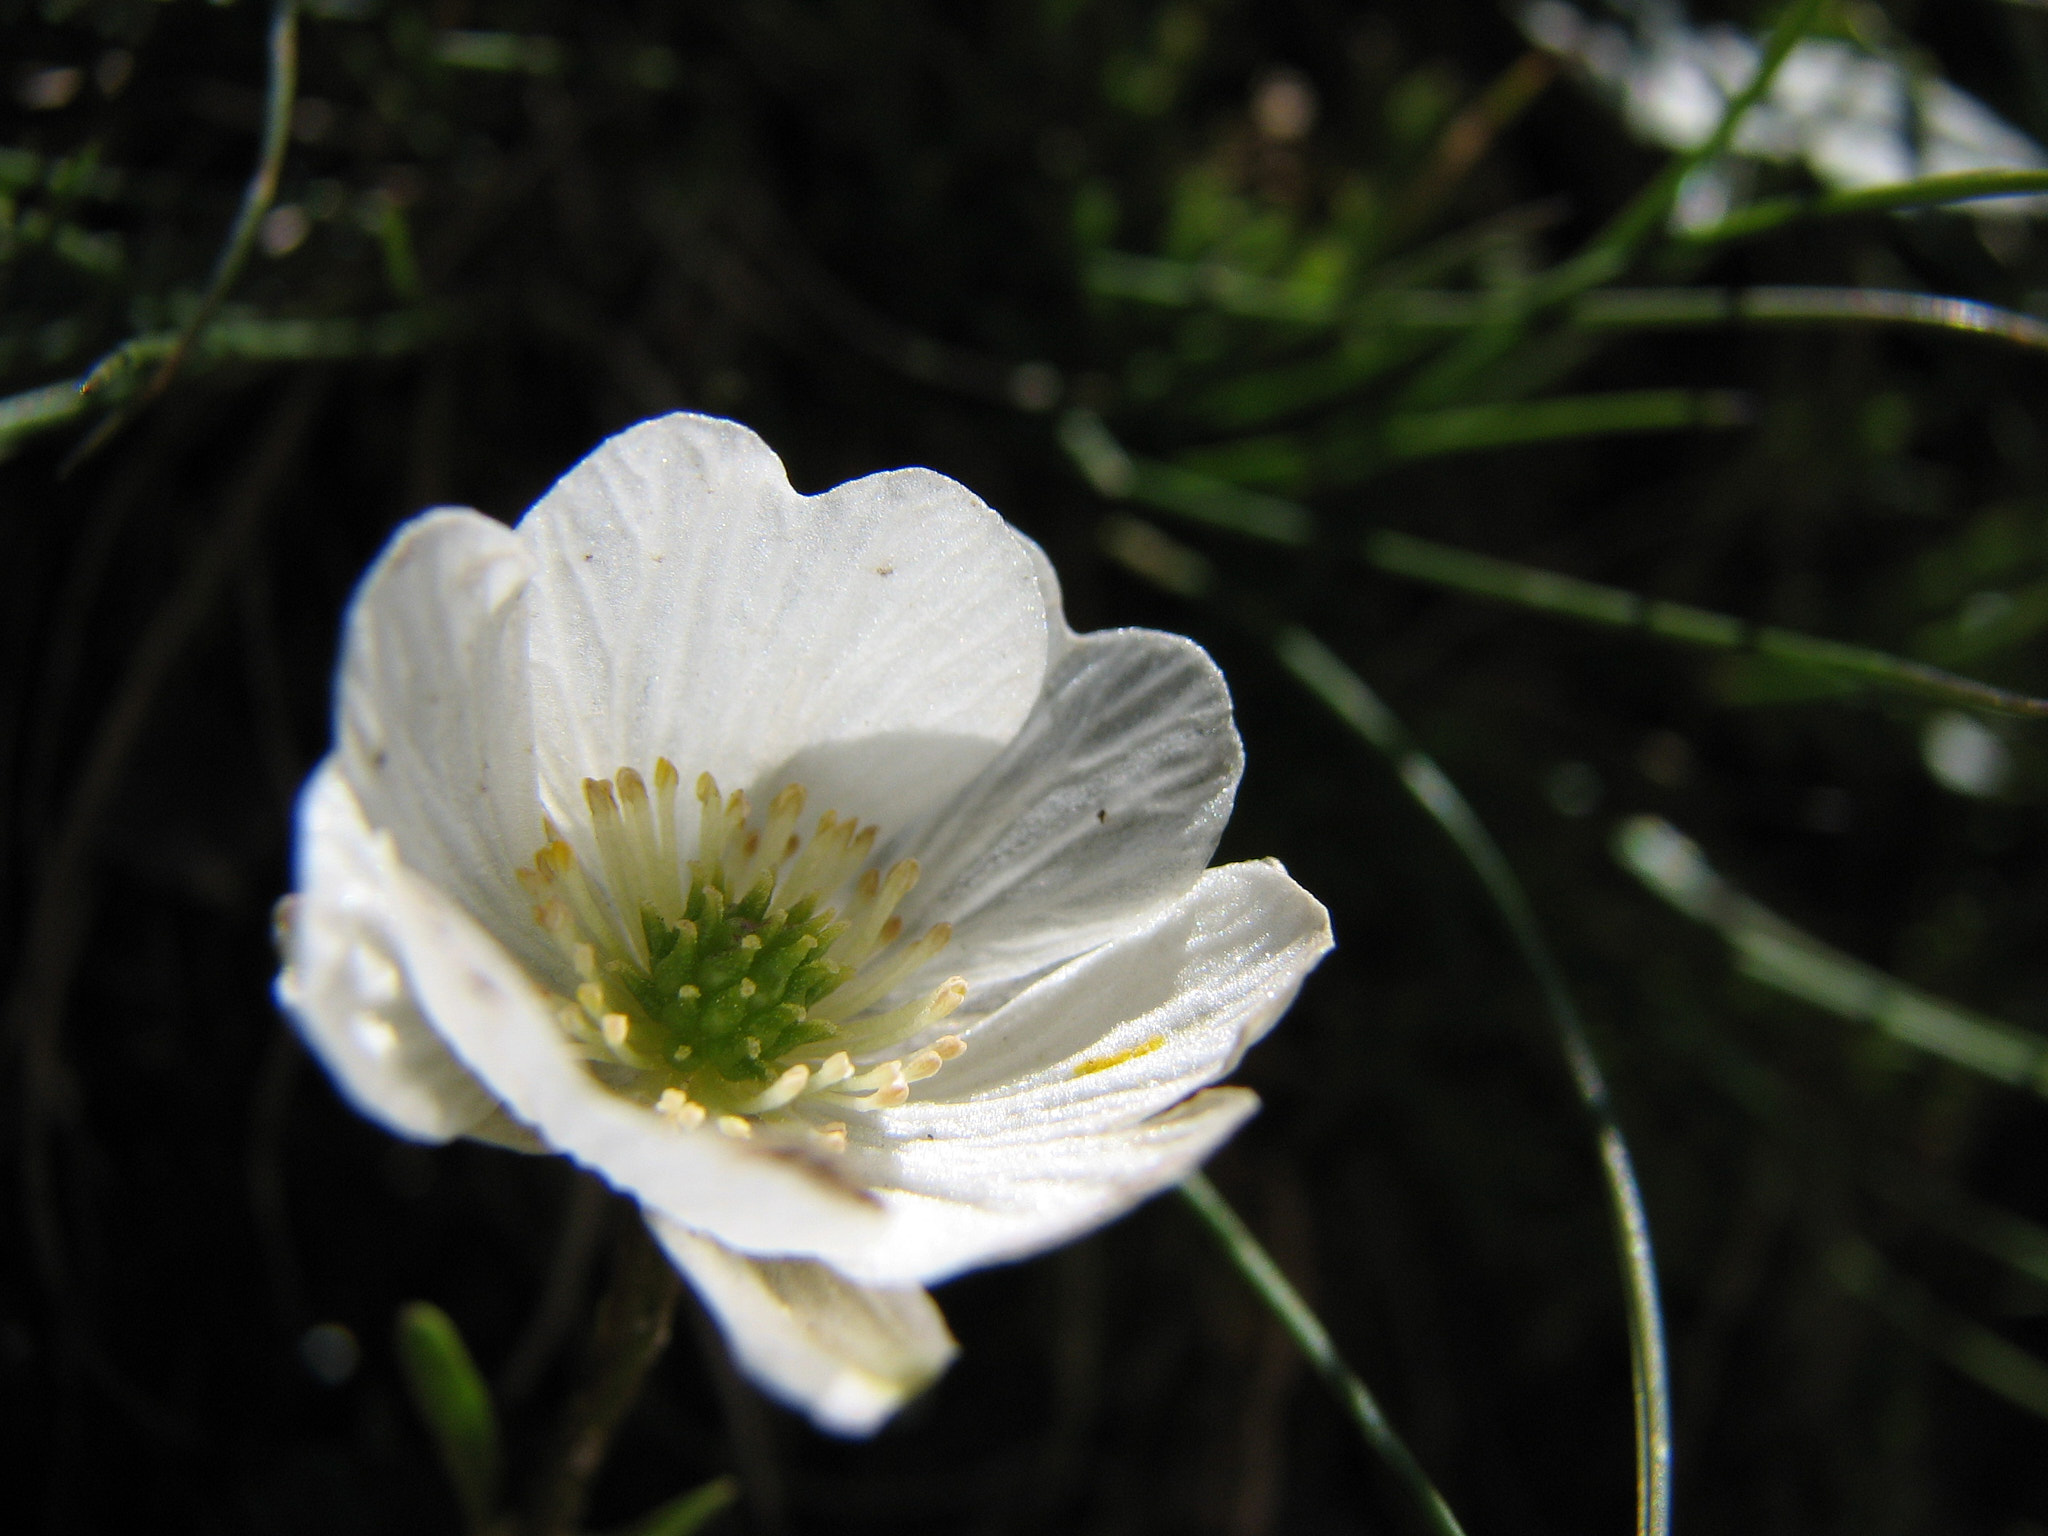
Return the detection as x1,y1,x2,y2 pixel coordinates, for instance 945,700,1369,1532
276,760,498,1141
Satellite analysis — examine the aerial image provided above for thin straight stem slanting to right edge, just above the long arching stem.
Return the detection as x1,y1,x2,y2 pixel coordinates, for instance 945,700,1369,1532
1360,528,2048,719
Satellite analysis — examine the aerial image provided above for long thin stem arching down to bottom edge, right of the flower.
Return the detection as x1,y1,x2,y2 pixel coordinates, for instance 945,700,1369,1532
1274,625,1671,1536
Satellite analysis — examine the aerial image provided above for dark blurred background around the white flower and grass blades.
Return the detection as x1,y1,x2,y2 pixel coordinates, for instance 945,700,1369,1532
0,0,2048,1536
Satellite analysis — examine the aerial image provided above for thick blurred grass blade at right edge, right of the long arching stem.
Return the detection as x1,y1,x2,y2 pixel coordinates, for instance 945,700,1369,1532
1614,815,2048,1098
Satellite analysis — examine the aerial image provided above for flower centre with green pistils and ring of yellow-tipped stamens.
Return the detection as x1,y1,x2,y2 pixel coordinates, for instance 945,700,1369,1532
518,758,967,1147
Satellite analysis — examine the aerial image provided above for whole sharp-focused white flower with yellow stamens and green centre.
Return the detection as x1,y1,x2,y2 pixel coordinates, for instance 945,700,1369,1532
279,416,1329,1434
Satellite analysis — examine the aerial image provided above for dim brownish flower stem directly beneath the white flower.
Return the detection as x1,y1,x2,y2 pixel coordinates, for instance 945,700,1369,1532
526,1210,682,1536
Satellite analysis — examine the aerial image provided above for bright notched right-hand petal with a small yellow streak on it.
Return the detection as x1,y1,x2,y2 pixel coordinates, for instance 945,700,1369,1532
834,860,1331,1284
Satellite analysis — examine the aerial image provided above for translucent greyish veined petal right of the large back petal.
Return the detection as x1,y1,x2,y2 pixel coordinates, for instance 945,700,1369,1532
905,629,1243,1010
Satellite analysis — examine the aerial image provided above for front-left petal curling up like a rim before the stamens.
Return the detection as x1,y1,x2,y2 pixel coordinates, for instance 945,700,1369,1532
299,770,883,1253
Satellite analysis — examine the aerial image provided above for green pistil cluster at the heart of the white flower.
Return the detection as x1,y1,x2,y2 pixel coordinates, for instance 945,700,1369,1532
604,877,852,1083
